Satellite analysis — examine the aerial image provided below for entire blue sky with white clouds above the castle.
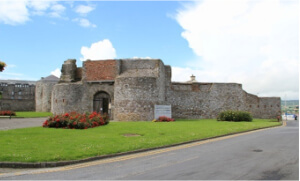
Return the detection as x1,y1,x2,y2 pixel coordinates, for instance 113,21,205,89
0,0,299,99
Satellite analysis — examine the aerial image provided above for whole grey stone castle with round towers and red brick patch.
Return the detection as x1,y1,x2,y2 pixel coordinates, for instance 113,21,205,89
36,59,281,121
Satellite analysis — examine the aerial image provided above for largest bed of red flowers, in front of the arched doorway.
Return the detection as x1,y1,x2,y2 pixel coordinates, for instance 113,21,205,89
43,112,109,129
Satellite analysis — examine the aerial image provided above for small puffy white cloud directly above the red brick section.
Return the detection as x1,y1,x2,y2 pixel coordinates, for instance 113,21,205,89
80,39,117,61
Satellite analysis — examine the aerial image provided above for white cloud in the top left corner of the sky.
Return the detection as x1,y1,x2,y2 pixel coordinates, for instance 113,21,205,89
0,0,30,25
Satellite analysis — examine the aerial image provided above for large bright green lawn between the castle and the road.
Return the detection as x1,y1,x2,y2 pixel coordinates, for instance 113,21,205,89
0,119,280,162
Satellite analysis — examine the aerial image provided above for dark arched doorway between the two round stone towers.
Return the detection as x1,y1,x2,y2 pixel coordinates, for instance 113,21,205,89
93,92,110,114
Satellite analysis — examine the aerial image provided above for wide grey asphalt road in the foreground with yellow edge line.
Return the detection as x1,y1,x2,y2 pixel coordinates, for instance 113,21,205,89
0,121,299,180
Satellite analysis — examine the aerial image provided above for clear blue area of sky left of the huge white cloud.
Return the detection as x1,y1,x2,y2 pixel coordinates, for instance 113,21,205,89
0,1,193,80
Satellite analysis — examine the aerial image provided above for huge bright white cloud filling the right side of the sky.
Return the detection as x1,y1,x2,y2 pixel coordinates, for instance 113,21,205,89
173,0,299,99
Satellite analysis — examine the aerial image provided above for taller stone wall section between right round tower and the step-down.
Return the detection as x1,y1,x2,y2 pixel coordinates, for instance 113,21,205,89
167,83,243,119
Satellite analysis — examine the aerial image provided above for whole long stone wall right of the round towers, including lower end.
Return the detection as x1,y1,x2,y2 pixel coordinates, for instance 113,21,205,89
167,83,281,119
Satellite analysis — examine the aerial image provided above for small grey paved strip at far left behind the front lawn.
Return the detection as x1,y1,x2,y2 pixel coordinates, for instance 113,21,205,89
0,118,47,131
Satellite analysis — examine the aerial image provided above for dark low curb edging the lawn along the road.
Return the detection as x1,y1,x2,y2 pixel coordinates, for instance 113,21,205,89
0,121,286,168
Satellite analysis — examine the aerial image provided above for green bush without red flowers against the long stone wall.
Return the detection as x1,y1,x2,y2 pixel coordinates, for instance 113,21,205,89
217,110,253,122
